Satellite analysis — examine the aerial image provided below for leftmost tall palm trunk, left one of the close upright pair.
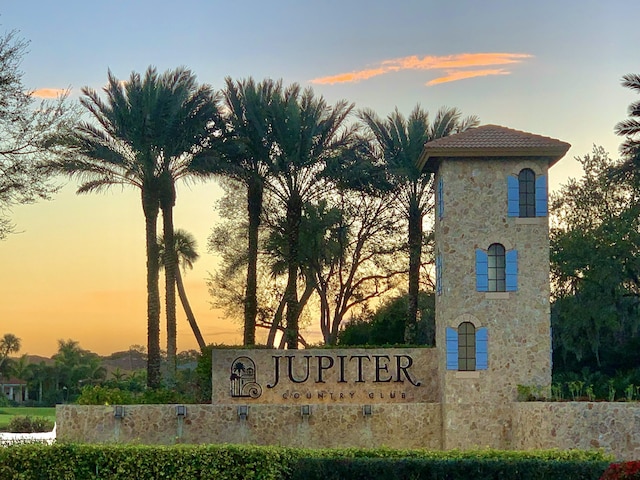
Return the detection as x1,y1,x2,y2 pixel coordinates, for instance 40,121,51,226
142,190,161,388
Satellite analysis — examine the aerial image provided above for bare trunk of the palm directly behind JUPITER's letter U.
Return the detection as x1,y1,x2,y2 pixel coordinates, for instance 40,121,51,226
285,194,302,350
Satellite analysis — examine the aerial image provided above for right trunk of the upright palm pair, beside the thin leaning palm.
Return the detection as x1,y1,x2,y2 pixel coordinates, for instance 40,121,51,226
161,192,178,383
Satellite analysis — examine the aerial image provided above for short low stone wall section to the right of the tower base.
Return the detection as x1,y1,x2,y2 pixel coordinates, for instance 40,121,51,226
513,402,640,460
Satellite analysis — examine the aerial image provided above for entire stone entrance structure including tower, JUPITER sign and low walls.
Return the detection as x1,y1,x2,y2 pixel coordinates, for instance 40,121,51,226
56,125,640,459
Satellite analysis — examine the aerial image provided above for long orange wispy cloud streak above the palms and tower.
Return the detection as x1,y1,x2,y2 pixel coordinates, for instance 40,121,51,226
311,53,532,86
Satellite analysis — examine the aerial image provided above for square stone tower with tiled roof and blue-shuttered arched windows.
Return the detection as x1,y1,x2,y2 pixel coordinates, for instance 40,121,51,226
419,125,570,448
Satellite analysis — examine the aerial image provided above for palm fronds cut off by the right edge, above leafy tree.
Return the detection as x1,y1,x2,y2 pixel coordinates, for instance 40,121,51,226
613,73,640,183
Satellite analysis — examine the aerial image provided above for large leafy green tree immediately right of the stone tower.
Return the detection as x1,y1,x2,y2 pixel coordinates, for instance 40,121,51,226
550,147,640,370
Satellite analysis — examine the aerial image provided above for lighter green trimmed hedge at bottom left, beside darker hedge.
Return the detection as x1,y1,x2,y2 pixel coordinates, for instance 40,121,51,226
0,443,292,480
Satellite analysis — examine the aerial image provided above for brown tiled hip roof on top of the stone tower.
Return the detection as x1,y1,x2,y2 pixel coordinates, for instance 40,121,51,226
418,125,571,171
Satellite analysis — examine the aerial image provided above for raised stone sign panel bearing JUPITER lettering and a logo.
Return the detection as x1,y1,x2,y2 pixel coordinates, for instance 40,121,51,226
212,348,440,405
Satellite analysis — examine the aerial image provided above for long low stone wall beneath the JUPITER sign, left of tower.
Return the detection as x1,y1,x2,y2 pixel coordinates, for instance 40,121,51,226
56,403,442,450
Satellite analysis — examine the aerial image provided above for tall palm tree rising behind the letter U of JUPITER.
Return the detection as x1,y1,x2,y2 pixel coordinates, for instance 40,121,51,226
266,84,355,349
